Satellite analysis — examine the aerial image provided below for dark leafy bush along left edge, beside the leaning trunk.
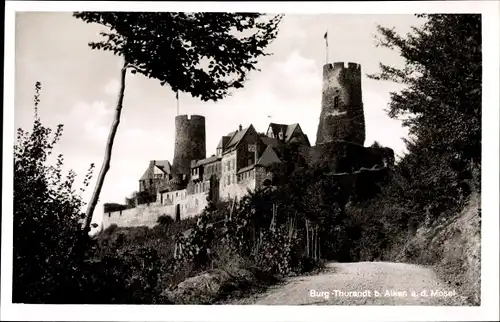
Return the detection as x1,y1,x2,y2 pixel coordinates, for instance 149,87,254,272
13,82,93,303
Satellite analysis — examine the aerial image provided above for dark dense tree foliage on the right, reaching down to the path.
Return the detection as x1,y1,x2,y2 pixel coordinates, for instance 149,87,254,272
349,14,482,261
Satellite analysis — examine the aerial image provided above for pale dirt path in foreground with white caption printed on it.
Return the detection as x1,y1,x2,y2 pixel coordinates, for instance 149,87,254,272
233,262,467,306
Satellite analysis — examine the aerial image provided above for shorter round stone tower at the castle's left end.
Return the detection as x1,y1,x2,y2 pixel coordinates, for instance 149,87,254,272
172,115,207,176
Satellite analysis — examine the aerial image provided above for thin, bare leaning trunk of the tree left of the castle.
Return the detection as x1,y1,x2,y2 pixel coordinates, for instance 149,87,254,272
83,63,127,234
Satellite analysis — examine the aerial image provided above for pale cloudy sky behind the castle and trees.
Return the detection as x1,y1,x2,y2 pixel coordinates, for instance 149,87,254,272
14,12,421,223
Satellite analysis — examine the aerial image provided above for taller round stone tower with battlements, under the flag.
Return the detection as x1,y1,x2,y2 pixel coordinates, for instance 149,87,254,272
316,62,365,146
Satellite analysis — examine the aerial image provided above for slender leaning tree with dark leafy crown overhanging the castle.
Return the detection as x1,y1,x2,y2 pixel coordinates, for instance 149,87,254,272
73,12,282,234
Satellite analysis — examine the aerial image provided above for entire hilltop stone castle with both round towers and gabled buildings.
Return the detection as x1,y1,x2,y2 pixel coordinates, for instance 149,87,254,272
102,62,394,229
